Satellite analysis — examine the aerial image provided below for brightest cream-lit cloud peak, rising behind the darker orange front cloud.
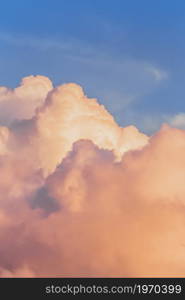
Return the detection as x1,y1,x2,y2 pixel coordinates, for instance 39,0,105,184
9,83,148,174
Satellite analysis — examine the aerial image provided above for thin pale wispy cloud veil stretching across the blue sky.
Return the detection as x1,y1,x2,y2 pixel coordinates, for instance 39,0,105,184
0,32,168,120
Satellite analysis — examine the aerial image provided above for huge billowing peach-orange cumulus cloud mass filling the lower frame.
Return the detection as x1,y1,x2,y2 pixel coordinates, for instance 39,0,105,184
0,77,185,277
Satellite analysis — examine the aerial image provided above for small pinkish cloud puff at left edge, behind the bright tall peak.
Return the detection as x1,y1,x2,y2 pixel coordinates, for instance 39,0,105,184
0,76,53,125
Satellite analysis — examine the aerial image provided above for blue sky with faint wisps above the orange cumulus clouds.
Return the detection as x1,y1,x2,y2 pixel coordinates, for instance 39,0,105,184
0,0,185,132
